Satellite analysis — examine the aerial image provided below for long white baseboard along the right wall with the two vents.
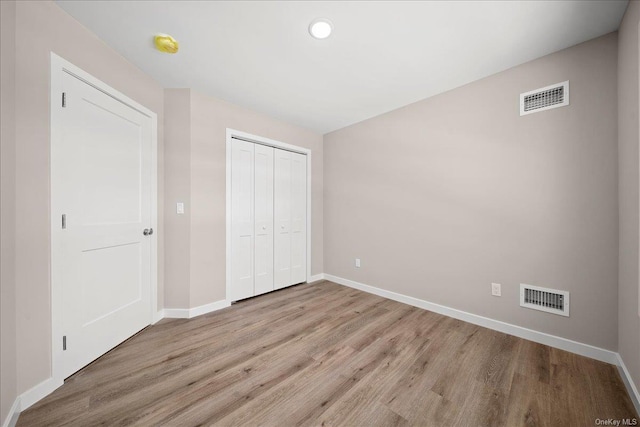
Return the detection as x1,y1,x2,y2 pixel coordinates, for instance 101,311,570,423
325,274,618,365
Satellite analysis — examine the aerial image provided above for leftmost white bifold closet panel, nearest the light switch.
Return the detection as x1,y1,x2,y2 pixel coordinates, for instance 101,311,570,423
230,139,255,301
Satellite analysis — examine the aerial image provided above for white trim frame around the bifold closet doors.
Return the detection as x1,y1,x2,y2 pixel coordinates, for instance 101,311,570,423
225,128,311,303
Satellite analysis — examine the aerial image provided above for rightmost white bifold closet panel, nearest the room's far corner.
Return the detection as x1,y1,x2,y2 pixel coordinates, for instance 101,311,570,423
291,153,307,284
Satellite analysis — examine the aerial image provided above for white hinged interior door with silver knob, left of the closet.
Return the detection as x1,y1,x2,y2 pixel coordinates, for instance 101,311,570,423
54,73,155,377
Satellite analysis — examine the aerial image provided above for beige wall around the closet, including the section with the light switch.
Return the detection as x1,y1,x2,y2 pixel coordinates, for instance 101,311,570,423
165,89,323,308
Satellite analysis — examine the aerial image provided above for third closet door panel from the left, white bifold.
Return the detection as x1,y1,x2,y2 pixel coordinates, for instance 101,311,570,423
273,149,293,289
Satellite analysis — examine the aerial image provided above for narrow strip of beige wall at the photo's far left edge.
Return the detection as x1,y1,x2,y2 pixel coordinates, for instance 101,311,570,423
0,1,17,422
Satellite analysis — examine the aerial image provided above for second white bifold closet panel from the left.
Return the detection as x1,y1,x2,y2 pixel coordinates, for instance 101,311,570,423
254,144,274,295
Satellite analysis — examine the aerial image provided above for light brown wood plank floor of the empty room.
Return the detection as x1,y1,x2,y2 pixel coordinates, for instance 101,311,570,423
18,282,638,427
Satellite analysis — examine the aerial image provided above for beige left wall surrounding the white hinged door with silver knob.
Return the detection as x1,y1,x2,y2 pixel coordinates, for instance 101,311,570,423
9,1,164,401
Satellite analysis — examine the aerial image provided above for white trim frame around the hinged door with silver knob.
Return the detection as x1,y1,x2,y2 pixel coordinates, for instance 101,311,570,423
49,52,161,385
